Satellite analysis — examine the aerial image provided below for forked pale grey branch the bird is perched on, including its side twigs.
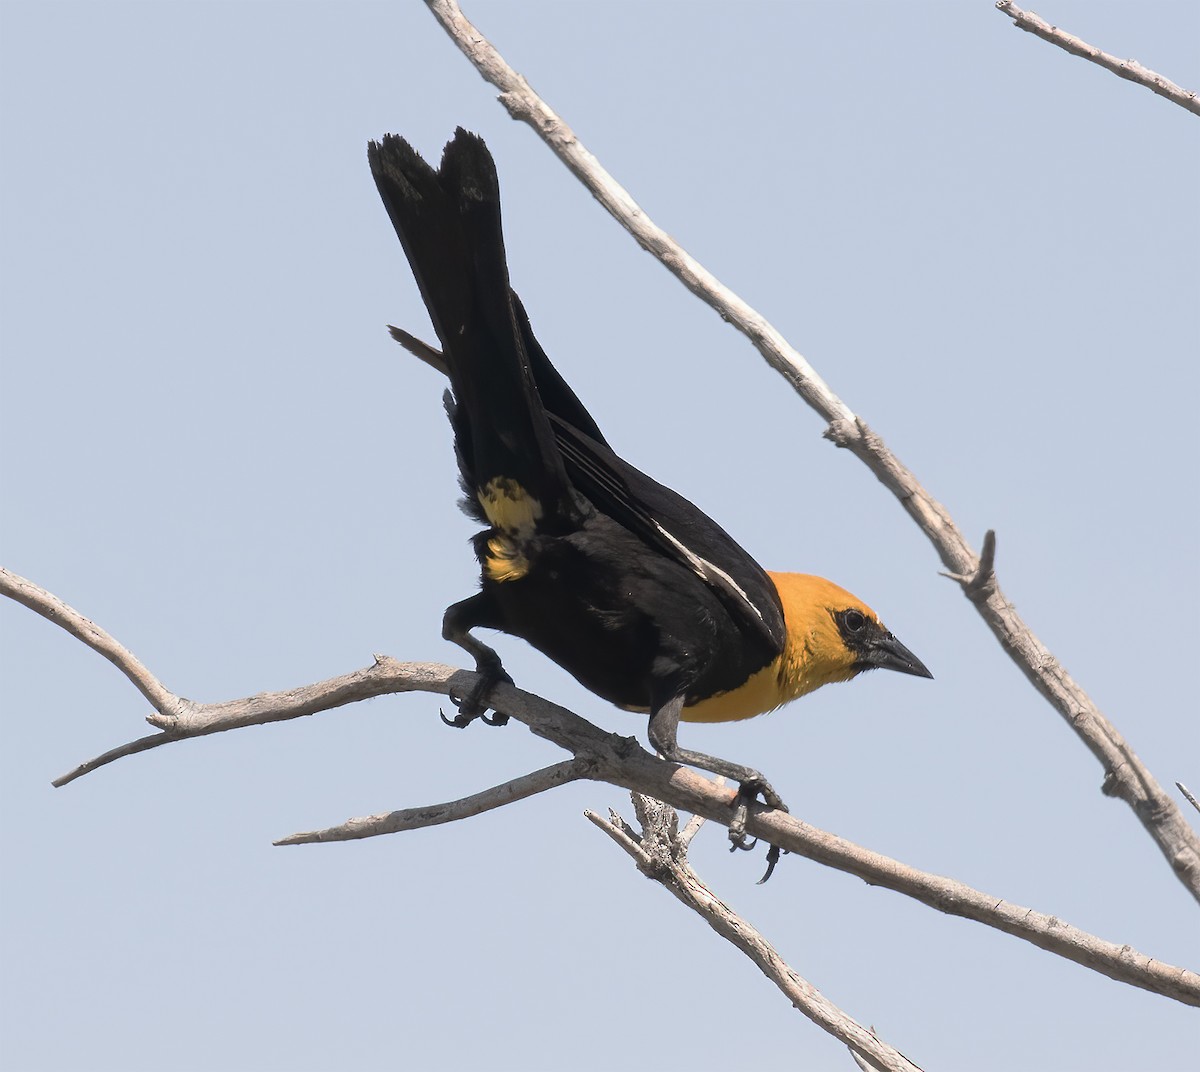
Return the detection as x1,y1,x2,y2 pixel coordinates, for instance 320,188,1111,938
0,568,1200,1006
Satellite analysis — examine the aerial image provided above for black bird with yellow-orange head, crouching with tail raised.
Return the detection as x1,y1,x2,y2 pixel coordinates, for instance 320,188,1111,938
367,127,932,881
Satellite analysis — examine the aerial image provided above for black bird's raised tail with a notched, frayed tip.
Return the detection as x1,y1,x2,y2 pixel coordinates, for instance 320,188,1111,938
367,128,575,529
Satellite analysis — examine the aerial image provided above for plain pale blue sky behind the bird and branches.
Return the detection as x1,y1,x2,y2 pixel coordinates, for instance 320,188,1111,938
0,0,1200,1072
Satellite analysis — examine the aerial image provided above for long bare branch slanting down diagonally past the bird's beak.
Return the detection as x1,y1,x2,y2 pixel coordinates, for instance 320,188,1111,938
426,0,1200,900
